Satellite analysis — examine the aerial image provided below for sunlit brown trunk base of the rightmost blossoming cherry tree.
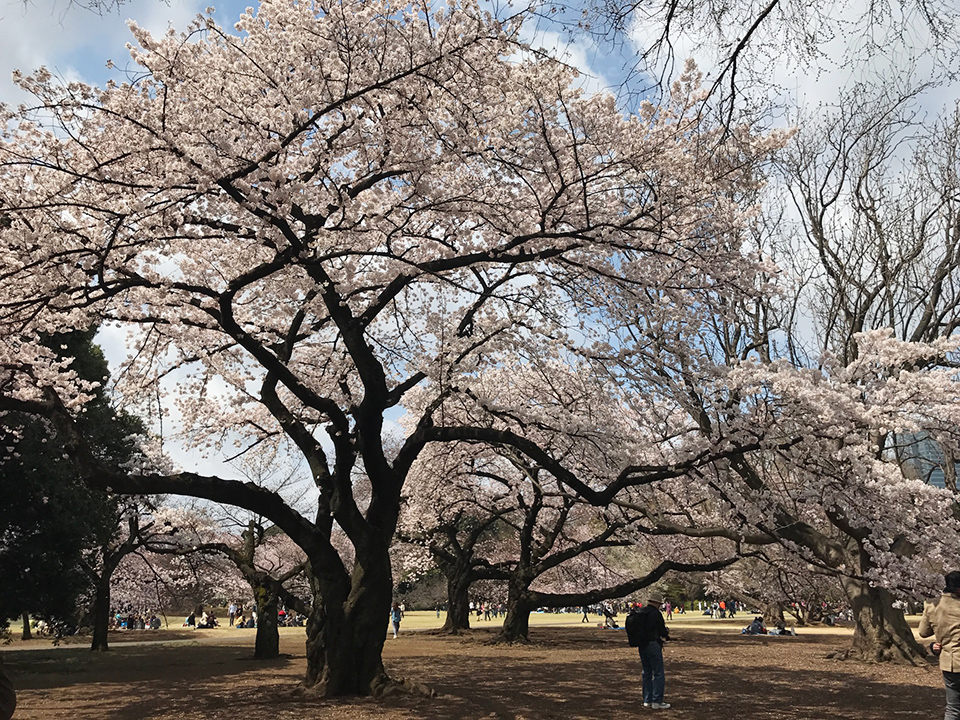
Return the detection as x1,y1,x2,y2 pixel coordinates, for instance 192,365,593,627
842,578,925,665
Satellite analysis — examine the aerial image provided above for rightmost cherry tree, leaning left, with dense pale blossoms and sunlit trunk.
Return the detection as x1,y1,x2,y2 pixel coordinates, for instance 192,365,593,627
664,331,960,662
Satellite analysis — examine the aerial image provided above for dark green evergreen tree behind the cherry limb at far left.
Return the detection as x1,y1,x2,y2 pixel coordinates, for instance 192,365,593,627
0,330,143,632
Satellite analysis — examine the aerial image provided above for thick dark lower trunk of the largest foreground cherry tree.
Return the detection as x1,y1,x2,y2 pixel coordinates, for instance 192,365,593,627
304,543,393,697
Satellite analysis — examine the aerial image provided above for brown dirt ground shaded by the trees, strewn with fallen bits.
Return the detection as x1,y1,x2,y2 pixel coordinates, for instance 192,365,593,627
3,618,943,720
